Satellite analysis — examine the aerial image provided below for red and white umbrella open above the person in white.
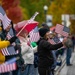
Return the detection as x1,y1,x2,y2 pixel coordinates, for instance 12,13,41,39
15,20,39,33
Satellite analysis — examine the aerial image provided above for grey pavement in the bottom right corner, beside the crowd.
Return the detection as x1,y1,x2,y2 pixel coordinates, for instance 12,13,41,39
59,52,75,75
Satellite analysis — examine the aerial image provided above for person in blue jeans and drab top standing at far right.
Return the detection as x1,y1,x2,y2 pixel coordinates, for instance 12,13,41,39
65,34,73,66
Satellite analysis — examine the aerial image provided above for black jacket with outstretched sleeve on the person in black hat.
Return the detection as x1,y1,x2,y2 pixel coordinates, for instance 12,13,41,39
37,38,63,68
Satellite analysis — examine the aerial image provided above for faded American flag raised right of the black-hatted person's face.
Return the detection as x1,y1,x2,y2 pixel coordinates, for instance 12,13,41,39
55,24,70,37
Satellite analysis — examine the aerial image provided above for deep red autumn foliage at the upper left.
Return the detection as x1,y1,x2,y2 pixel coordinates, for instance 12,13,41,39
2,0,22,23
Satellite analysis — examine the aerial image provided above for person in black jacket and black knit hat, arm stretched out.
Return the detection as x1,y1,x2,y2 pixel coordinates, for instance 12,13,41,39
37,28,66,75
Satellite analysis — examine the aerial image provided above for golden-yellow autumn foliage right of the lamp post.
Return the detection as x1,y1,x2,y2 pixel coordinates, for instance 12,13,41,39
48,0,75,33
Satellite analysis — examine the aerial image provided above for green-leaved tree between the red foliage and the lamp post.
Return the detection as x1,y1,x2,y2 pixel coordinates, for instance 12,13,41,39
21,0,50,26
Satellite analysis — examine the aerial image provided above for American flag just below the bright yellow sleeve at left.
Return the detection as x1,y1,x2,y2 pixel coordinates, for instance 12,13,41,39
1,46,19,56
